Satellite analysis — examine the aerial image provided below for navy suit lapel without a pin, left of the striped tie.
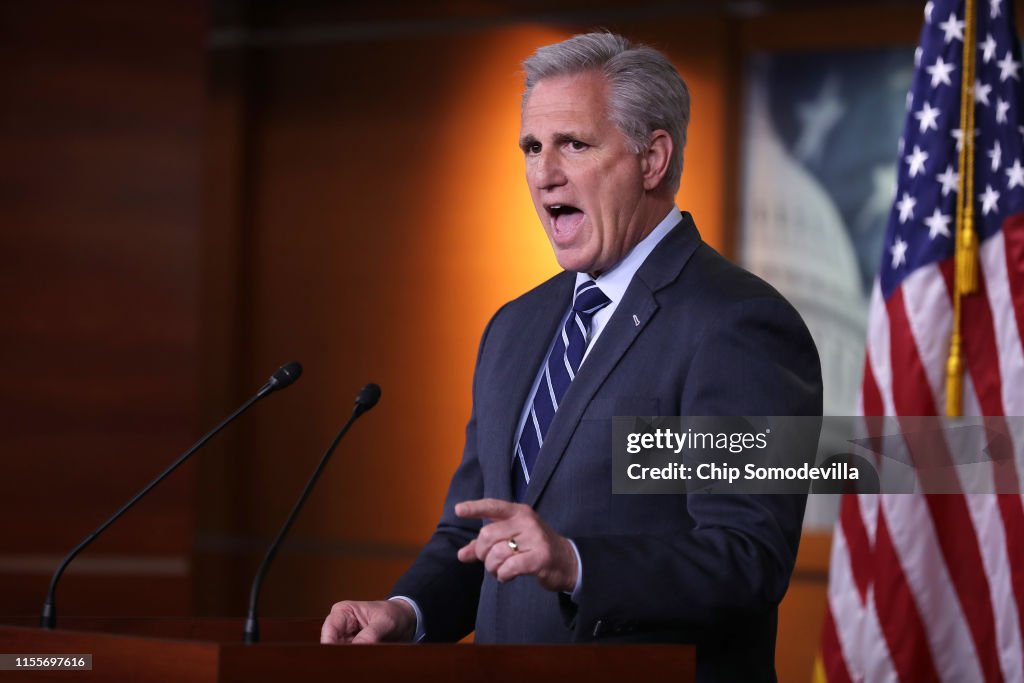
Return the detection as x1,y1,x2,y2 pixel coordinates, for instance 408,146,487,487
495,272,575,500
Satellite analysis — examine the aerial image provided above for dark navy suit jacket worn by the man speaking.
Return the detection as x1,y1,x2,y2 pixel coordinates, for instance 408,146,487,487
392,213,821,681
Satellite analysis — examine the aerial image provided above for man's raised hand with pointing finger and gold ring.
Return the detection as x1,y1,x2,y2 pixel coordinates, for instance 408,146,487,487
455,498,579,592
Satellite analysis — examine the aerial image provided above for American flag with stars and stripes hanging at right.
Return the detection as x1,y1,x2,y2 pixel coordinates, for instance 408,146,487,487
816,0,1024,681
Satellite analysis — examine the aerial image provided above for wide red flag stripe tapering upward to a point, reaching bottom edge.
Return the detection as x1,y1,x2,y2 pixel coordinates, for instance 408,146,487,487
873,508,941,682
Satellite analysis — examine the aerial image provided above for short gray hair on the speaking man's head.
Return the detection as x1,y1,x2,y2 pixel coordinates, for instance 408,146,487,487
522,33,690,194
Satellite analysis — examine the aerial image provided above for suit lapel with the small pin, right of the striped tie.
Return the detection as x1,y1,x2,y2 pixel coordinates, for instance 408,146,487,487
524,213,700,506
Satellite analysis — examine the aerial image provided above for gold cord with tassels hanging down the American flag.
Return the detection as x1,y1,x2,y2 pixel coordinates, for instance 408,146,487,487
946,0,978,417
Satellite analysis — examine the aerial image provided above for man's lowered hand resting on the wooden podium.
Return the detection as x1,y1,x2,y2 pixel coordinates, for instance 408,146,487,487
321,600,416,645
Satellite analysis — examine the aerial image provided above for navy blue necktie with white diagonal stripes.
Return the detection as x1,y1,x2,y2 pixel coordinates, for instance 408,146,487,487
512,280,611,501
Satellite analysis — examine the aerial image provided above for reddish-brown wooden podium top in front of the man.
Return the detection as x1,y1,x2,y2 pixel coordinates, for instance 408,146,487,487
0,617,696,683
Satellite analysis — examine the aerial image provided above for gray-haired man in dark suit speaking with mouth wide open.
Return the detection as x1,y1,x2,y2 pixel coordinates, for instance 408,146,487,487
322,34,821,681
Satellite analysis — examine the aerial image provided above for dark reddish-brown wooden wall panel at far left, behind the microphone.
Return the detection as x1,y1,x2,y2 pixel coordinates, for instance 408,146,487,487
0,0,205,614
